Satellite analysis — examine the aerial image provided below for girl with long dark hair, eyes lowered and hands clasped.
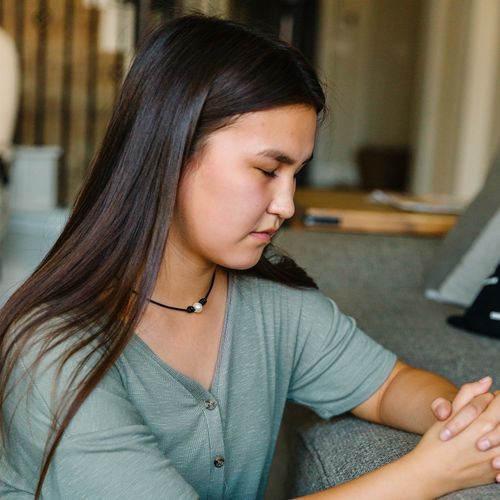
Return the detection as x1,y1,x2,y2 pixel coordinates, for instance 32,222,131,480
0,16,500,500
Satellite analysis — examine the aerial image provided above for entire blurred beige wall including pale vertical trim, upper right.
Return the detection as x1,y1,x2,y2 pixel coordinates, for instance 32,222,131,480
311,0,500,200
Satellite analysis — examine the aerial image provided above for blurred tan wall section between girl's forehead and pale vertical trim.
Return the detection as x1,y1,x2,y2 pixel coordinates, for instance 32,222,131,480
311,0,421,185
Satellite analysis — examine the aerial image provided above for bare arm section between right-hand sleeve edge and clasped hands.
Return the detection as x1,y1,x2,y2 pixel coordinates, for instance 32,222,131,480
379,366,458,434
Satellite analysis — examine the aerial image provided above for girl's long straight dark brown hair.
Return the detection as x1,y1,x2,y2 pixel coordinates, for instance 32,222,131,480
0,15,324,498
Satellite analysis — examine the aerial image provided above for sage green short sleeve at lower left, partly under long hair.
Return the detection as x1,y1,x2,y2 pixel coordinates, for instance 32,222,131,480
0,318,199,500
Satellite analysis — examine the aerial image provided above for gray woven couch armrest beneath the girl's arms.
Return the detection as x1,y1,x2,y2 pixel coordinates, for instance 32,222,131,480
287,416,500,500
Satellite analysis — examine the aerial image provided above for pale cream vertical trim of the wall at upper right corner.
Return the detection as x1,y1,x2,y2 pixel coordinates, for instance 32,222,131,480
412,0,500,200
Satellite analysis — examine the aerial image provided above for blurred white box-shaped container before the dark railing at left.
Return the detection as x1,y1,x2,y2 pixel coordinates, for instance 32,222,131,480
9,146,62,211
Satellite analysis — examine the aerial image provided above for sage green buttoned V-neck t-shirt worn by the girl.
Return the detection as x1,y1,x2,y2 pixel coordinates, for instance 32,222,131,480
0,276,396,500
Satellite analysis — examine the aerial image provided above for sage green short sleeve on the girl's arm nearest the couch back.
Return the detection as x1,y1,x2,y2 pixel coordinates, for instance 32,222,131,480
288,290,397,418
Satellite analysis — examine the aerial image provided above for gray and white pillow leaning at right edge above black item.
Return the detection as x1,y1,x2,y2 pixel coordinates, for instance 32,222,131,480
426,155,500,307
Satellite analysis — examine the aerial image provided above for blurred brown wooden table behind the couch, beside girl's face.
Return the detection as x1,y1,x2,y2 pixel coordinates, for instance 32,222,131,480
291,188,458,236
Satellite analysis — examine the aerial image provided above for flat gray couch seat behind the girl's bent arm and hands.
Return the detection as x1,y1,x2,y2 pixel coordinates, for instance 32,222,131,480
333,289,500,388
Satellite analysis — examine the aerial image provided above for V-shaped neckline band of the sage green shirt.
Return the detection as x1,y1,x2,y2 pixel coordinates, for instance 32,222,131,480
130,273,236,395
